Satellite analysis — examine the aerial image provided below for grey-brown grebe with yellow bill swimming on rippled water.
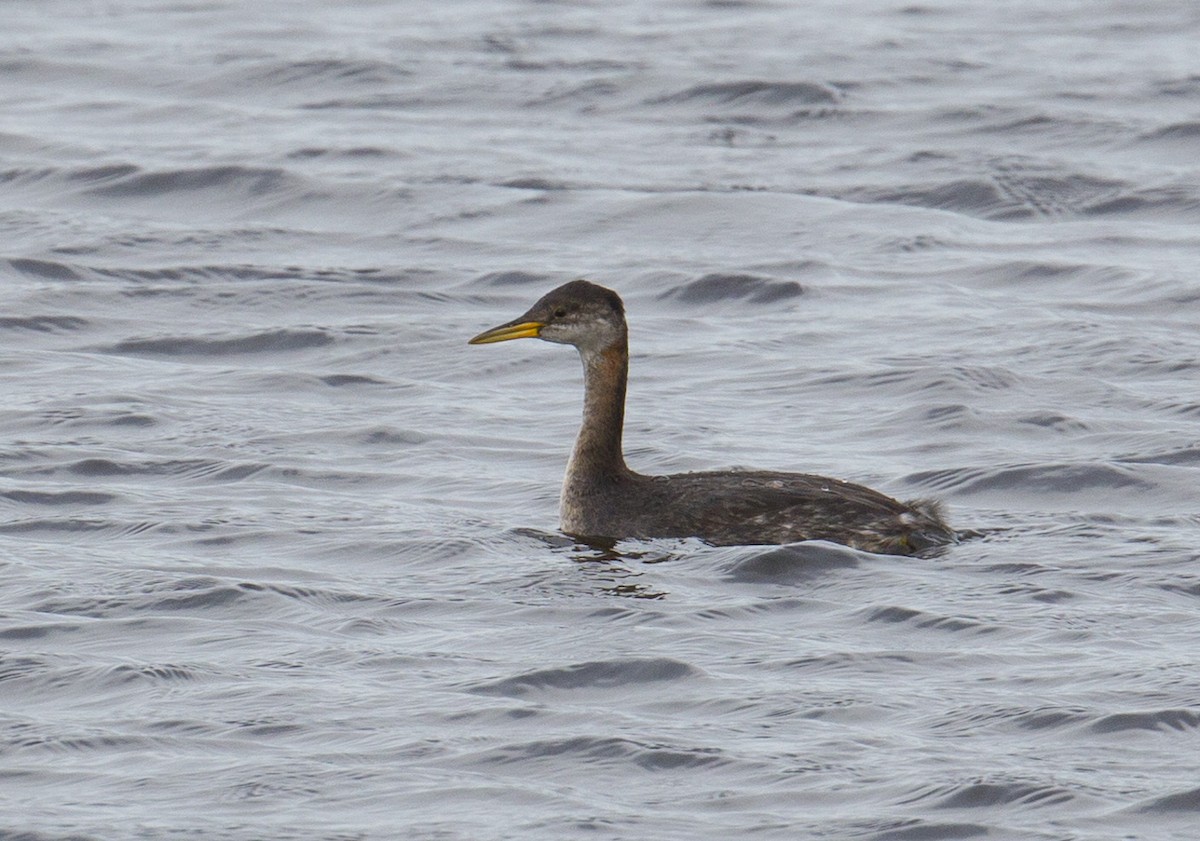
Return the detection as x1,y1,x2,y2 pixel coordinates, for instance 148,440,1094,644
469,280,955,554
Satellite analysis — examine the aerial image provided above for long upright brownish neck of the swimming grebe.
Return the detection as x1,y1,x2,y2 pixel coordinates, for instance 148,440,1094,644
568,336,629,480
